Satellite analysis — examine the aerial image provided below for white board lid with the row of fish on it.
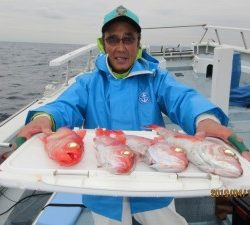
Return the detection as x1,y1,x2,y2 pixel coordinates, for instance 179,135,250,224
0,130,250,197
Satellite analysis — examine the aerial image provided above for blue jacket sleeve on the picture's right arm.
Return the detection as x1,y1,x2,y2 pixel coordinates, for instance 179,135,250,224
155,70,228,134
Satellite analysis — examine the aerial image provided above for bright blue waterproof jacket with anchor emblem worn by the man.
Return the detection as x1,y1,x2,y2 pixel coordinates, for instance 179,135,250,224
26,52,228,220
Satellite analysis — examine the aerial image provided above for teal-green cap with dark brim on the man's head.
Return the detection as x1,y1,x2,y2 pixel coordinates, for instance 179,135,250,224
102,5,141,33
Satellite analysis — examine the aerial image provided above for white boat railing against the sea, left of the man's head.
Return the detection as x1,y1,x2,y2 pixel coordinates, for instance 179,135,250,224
49,44,97,85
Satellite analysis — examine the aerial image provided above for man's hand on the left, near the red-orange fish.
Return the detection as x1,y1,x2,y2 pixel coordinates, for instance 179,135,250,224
17,116,52,139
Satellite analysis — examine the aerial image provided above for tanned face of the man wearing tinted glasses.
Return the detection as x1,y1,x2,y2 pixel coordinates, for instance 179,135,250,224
103,21,139,73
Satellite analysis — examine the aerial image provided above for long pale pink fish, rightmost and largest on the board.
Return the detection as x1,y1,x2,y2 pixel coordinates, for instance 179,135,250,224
147,125,243,178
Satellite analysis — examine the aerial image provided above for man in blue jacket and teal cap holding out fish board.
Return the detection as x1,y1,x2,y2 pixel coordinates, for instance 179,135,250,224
19,6,248,225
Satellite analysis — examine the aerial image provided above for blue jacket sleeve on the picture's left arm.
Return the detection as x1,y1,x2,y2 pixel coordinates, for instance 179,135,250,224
26,75,89,129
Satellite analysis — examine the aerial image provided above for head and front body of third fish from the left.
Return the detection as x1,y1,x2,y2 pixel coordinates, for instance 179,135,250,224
143,141,188,173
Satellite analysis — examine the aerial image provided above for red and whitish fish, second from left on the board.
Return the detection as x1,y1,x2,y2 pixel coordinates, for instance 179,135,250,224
93,128,136,175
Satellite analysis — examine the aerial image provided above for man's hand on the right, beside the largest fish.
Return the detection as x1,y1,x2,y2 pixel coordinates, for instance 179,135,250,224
197,119,250,161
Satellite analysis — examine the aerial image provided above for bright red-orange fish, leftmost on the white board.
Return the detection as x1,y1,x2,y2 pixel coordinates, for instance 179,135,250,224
41,127,86,166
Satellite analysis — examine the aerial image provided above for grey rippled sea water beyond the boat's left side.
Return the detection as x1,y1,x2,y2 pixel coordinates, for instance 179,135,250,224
0,42,86,121
